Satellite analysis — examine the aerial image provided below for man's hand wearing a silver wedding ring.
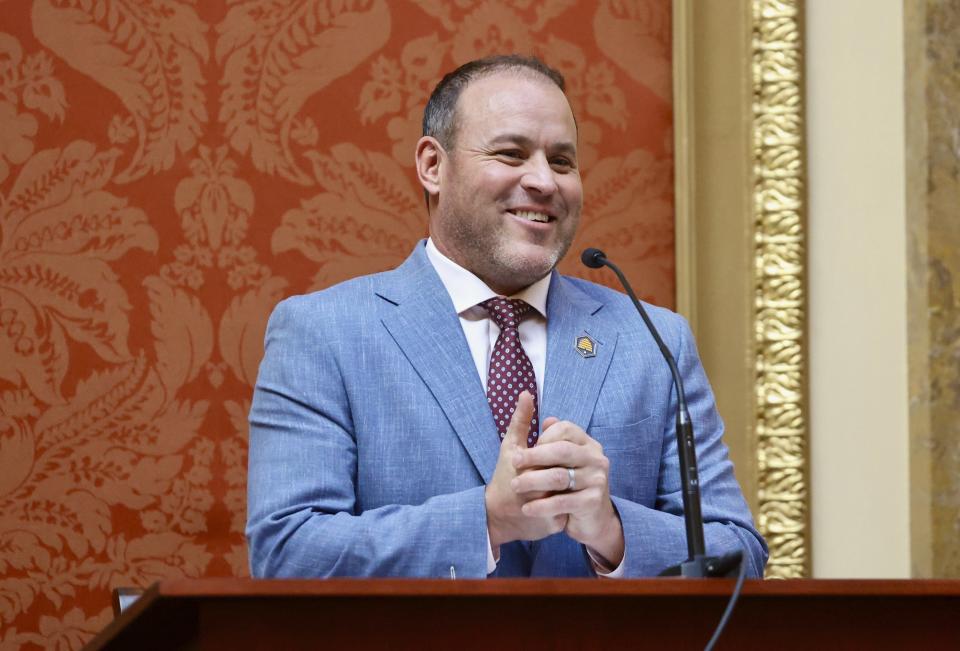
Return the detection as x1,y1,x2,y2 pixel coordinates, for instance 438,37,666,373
511,417,624,567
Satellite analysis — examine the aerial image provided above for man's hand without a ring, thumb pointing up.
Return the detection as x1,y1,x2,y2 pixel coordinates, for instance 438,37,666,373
484,391,568,556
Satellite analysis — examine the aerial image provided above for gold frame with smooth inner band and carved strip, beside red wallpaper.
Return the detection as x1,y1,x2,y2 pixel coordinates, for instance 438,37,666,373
674,0,811,578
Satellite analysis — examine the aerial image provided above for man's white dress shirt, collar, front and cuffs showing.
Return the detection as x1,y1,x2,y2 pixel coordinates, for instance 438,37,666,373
427,238,623,578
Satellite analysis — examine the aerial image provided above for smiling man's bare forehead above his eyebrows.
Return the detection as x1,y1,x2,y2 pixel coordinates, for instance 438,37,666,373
457,70,577,141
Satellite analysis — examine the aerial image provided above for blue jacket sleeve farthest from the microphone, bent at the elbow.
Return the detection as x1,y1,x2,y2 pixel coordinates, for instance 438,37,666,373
246,298,488,578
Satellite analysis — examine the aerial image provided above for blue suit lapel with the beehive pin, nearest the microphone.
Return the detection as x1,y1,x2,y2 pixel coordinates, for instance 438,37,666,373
540,272,618,429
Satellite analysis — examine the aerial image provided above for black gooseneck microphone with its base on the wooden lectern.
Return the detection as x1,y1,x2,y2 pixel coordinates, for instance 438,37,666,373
580,248,741,578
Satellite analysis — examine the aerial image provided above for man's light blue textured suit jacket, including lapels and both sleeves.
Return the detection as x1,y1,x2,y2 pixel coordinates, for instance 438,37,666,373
247,242,767,578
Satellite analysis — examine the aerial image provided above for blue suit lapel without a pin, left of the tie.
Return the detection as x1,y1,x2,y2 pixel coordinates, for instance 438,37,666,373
377,243,500,483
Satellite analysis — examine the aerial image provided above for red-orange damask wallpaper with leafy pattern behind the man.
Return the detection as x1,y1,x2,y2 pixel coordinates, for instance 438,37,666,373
0,0,674,649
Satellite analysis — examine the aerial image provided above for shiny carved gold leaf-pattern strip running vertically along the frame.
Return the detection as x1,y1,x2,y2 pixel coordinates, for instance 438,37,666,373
751,0,810,578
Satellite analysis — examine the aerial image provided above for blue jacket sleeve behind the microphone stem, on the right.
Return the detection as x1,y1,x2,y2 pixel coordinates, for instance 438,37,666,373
612,317,768,577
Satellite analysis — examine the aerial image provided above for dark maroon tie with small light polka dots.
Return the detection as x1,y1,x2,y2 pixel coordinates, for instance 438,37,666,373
480,296,540,447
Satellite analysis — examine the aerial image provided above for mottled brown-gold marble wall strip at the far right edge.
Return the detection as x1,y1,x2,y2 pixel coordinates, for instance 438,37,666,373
904,0,960,577
